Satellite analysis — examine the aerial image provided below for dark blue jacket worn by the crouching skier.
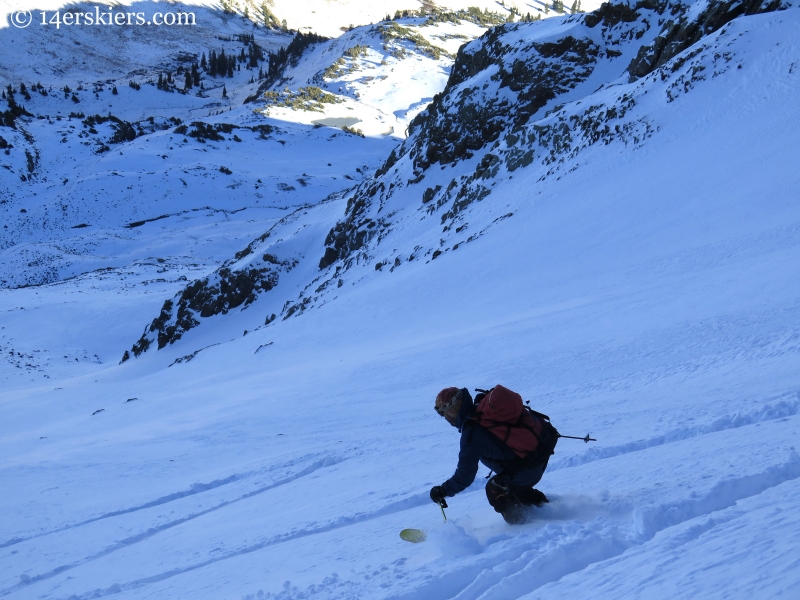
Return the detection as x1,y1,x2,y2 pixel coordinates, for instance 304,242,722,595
442,388,519,496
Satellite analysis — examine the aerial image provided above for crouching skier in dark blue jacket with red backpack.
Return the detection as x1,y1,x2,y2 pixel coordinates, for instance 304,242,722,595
430,385,559,524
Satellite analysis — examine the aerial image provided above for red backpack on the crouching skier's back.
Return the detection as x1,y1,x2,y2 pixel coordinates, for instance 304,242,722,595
475,385,559,460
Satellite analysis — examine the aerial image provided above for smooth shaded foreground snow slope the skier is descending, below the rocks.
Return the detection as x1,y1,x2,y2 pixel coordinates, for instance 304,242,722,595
0,1,800,600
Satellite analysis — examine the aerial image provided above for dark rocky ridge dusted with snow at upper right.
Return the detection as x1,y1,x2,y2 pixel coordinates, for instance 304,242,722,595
312,0,789,276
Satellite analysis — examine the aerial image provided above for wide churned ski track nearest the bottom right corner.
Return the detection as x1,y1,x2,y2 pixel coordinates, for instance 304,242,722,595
380,450,800,600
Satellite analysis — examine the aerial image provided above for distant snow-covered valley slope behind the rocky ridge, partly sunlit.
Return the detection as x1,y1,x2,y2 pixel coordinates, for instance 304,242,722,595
0,3,510,290
